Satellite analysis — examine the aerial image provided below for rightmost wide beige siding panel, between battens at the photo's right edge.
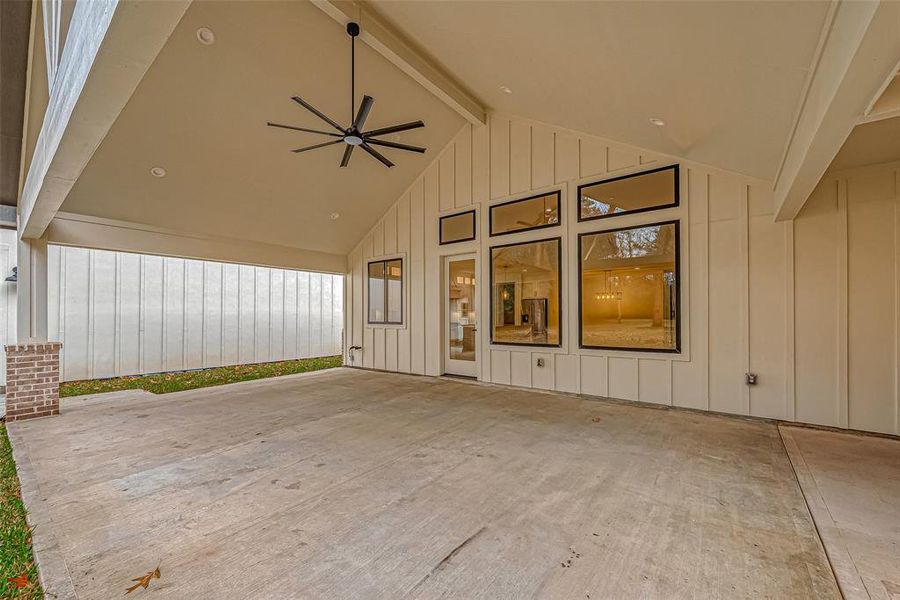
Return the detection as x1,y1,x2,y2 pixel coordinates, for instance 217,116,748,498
847,173,897,433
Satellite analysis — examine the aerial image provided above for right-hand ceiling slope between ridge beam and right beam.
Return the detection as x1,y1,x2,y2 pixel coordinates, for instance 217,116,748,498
374,0,828,179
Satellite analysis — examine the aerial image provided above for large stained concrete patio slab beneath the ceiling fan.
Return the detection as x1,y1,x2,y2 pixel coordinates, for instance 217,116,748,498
10,368,864,600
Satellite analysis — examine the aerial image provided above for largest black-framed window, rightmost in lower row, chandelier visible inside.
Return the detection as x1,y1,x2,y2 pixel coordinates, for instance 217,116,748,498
578,221,681,352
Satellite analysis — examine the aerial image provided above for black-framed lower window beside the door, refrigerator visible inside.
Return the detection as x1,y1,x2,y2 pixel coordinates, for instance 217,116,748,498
491,238,562,346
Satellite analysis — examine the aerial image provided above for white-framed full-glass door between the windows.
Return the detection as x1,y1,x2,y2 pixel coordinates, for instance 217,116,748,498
444,254,478,377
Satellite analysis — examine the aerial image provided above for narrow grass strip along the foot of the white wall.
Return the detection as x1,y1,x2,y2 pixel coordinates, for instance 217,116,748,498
58,356,341,398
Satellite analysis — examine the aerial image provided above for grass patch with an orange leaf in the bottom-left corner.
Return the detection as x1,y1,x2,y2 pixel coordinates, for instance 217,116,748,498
0,425,44,600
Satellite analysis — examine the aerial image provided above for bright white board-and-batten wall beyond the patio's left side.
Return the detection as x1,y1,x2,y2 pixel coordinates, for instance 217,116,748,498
45,246,344,381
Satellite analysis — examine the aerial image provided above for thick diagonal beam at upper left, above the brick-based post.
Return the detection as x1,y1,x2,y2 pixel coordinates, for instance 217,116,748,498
19,0,190,239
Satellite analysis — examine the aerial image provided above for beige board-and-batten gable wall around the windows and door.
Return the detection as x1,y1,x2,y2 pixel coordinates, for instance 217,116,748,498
345,114,900,433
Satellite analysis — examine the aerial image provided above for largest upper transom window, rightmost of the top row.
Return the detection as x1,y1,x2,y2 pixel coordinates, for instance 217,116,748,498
578,165,679,221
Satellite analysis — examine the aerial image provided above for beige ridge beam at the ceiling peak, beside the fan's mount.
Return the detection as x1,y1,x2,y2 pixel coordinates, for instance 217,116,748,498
311,0,487,125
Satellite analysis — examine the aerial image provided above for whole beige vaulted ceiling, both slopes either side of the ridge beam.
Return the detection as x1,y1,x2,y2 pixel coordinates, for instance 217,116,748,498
62,0,828,254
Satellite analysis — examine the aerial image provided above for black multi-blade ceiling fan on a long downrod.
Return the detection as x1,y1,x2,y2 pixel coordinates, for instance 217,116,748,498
266,22,425,168
